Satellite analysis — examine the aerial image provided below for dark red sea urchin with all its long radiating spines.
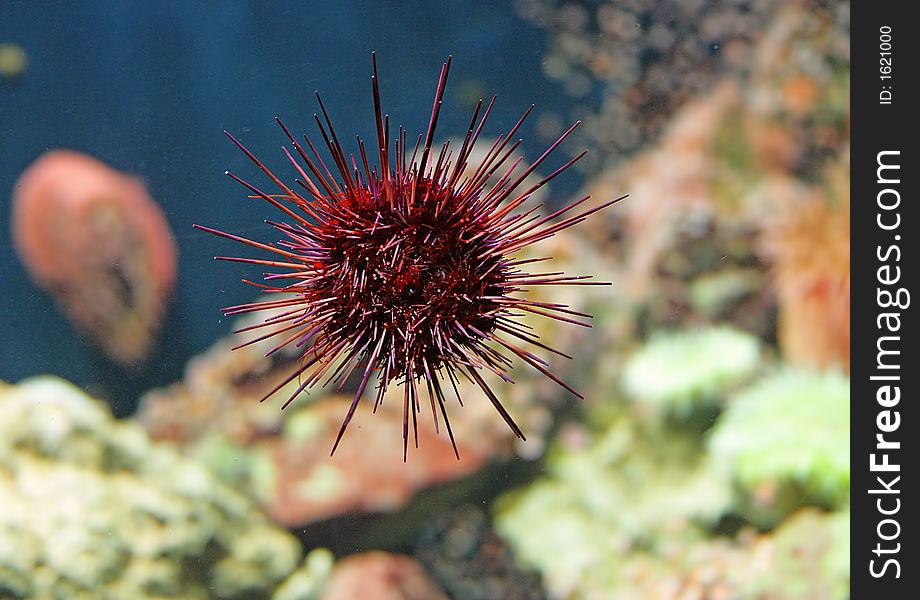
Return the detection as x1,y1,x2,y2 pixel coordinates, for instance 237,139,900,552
196,57,621,460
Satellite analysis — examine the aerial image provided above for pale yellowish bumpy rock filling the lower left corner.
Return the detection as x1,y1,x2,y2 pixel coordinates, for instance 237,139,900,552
0,377,316,598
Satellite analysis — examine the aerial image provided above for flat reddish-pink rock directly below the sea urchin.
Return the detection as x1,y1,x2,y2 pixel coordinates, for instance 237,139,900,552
244,395,495,526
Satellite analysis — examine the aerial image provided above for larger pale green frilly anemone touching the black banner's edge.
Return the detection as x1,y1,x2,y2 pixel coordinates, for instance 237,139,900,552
709,369,850,523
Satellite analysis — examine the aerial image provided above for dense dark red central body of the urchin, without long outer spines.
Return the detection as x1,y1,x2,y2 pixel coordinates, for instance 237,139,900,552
314,176,511,379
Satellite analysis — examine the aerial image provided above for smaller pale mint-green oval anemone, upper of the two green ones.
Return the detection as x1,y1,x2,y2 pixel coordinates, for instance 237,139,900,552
622,327,760,416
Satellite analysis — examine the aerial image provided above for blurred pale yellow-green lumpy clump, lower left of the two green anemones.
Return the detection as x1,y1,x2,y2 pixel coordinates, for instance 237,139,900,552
495,415,731,597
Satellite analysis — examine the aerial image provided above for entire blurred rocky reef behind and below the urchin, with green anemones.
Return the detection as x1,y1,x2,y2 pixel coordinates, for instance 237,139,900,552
0,0,850,600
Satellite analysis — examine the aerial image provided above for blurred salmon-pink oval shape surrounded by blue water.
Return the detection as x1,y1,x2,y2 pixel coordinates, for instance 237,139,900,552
11,150,176,365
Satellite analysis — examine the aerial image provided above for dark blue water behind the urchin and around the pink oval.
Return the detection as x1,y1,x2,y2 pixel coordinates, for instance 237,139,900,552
0,0,575,413
